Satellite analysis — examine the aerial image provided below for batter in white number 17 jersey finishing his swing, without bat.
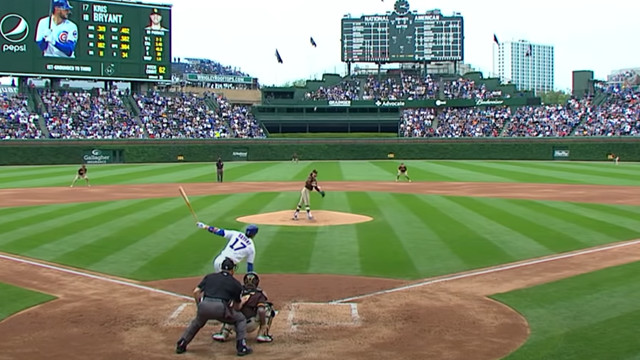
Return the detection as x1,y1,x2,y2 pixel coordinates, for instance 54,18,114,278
196,222,258,272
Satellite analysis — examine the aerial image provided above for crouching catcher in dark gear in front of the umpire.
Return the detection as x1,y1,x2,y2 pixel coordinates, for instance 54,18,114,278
211,272,276,343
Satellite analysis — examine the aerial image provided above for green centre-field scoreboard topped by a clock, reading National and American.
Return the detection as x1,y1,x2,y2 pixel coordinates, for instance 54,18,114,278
341,0,464,63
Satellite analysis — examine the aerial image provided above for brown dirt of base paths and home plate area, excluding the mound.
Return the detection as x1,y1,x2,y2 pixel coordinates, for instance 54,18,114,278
0,182,640,360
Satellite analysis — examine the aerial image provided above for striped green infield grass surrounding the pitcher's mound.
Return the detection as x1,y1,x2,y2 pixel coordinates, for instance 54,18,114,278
0,192,640,280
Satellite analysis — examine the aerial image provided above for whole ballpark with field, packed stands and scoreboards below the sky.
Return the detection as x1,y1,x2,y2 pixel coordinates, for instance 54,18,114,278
0,0,640,360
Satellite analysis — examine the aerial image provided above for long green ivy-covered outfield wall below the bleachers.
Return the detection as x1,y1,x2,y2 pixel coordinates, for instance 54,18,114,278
0,137,640,165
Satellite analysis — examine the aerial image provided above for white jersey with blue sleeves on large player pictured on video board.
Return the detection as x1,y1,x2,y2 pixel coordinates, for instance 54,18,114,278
36,16,78,58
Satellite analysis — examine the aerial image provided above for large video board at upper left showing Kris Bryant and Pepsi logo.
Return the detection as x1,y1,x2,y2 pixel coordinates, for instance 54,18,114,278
0,0,171,82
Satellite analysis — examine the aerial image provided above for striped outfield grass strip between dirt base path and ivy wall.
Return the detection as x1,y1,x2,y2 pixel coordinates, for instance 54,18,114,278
0,160,640,188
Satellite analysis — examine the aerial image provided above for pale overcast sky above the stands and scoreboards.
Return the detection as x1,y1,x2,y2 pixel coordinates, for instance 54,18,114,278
159,0,640,90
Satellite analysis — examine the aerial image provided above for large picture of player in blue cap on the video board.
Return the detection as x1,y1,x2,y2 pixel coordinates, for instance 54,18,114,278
35,0,78,58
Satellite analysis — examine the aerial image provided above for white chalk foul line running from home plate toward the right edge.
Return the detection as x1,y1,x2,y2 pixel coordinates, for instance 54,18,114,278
329,239,640,304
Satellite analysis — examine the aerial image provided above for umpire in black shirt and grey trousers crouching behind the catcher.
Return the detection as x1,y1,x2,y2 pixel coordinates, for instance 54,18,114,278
176,259,253,356
